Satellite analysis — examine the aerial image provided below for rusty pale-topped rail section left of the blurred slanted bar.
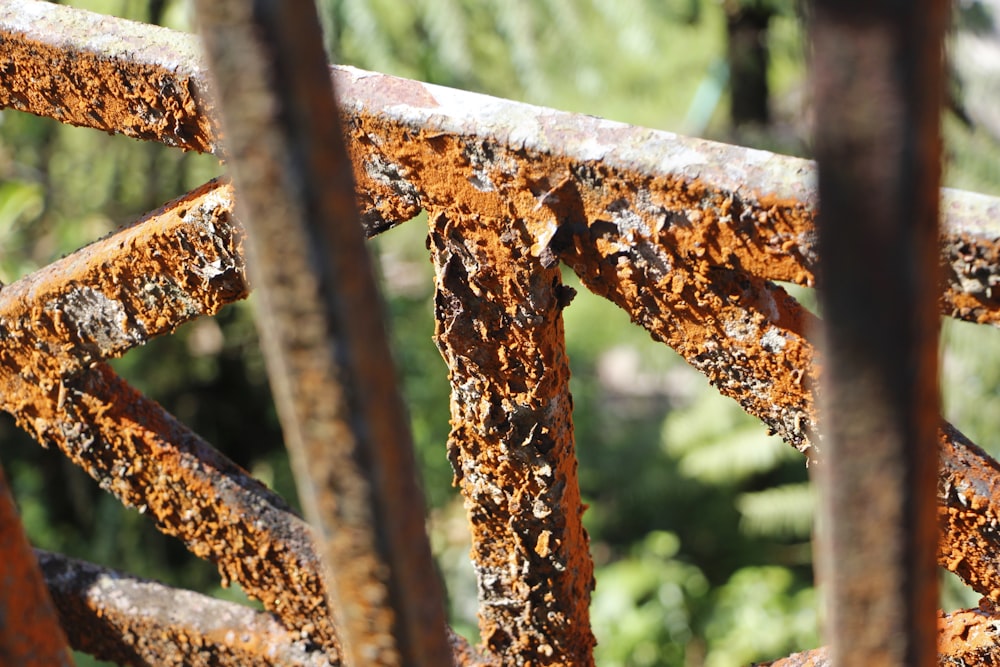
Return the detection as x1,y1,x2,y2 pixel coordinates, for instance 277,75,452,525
0,0,215,152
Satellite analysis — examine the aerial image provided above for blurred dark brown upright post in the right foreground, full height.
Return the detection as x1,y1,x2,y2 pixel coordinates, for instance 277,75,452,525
811,0,948,665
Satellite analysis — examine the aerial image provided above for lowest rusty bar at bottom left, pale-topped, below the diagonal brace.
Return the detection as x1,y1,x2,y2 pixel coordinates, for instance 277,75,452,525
37,551,341,667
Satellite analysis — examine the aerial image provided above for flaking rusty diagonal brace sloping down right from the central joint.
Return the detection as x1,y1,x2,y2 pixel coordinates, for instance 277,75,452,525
555,211,1000,601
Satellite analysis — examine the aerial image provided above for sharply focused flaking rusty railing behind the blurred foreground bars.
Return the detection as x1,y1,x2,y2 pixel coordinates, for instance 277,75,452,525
0,0,1000,665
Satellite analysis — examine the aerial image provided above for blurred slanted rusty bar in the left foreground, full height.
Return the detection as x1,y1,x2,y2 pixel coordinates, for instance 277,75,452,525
190,0,451,667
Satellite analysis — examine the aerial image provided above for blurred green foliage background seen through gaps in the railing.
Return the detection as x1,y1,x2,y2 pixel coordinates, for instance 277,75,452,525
0,0,1000,667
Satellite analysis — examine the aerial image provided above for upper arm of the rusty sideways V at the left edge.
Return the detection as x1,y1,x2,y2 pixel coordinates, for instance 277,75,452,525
0,181,248,380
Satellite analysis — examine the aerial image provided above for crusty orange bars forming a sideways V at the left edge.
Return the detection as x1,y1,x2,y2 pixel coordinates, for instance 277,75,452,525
0,184,337,650
